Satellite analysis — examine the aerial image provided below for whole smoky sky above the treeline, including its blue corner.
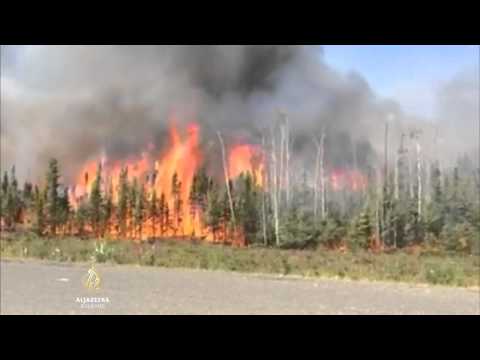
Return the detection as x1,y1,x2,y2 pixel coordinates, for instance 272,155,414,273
0,45,480,181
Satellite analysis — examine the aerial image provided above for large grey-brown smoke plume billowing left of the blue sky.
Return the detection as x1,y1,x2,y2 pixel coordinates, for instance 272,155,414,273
0,45,478,184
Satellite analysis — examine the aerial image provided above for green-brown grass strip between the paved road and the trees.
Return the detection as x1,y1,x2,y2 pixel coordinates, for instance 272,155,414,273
0,234,480,287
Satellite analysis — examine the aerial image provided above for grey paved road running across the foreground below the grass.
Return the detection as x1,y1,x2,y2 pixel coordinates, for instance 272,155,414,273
0,261,480,315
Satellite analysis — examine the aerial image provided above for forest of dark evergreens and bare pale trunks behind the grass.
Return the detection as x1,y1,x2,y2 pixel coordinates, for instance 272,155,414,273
0,119,480,254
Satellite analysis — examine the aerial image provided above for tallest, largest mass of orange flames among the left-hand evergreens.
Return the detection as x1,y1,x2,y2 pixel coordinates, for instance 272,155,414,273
69,120,202,236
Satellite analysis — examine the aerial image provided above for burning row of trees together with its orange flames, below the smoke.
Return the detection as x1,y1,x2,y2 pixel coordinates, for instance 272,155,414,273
0,118,479,255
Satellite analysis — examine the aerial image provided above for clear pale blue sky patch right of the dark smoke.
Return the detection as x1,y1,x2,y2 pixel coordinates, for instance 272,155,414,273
323,45,480,117
